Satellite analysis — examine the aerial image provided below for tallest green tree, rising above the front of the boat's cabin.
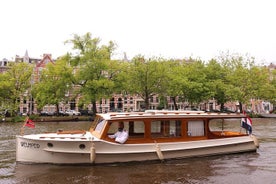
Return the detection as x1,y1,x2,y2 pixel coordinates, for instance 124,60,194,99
67,33,117,113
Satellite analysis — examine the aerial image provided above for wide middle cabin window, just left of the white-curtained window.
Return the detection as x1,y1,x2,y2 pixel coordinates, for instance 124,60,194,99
151,120,181,137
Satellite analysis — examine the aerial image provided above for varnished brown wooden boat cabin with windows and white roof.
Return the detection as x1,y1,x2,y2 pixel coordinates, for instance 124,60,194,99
90,111,247,144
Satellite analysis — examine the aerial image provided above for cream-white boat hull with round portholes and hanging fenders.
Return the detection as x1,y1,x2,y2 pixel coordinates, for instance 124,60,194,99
16,132,258,164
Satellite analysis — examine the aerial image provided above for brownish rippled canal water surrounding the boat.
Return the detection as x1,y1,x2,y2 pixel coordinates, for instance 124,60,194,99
0,118,276,184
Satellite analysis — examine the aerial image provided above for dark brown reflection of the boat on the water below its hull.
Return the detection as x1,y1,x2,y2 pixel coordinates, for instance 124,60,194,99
16,158,216,183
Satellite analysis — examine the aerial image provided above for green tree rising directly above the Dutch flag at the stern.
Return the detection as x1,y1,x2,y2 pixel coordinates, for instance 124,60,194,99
218,54,268,112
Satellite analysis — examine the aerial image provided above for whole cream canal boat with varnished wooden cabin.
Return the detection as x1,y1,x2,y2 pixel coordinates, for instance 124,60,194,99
16,110,259,164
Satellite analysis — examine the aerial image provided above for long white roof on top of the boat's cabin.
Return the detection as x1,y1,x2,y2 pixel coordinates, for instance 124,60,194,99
97,110,246,120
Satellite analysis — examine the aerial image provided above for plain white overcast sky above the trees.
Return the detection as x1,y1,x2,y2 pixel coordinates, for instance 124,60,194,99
0,0,276,64
